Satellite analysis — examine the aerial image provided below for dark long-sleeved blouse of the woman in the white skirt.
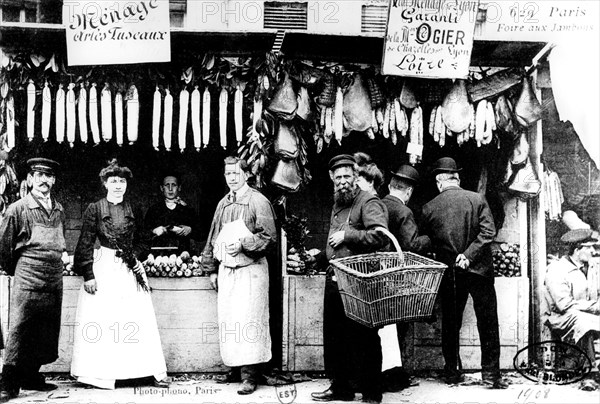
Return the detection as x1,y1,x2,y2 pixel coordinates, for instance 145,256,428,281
73,198,147,281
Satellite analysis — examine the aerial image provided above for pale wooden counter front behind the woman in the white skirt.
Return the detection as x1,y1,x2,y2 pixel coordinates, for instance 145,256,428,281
0,276,226,372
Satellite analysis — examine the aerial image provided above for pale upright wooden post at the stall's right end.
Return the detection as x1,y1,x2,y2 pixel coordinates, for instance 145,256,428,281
527,68,546,356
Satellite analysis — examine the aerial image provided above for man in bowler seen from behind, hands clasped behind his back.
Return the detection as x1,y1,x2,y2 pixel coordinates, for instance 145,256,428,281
422,157,508,388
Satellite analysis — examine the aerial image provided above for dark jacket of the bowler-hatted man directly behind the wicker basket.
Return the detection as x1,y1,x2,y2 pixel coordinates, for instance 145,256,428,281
382,195,431,254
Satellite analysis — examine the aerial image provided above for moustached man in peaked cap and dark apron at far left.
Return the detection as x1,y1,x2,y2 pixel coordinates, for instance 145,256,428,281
0,158,65,402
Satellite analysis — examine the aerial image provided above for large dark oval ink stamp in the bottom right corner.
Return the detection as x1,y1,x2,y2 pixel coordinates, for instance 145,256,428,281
513,341,592,384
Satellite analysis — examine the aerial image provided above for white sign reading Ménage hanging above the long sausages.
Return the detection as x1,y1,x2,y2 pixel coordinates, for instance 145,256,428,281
63,0,171,66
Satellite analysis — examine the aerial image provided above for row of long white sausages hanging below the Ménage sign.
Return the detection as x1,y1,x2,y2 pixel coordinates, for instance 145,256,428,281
1,82,247,152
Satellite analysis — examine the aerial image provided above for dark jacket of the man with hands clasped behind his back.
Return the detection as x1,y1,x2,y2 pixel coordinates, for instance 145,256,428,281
421,186,496,277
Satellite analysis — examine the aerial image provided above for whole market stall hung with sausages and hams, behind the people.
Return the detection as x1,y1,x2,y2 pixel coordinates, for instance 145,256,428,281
0,0,596,372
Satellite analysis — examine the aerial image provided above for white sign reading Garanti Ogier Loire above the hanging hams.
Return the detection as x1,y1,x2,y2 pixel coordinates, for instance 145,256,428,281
382,0,479,78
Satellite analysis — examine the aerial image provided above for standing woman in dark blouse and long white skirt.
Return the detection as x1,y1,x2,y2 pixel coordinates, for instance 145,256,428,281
71,160,168,389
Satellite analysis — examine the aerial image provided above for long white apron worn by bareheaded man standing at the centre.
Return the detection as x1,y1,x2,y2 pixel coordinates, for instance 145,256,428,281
215,219,271,367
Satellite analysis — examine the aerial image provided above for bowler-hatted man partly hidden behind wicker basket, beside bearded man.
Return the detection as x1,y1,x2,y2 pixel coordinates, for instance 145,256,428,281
382,164,431,387
